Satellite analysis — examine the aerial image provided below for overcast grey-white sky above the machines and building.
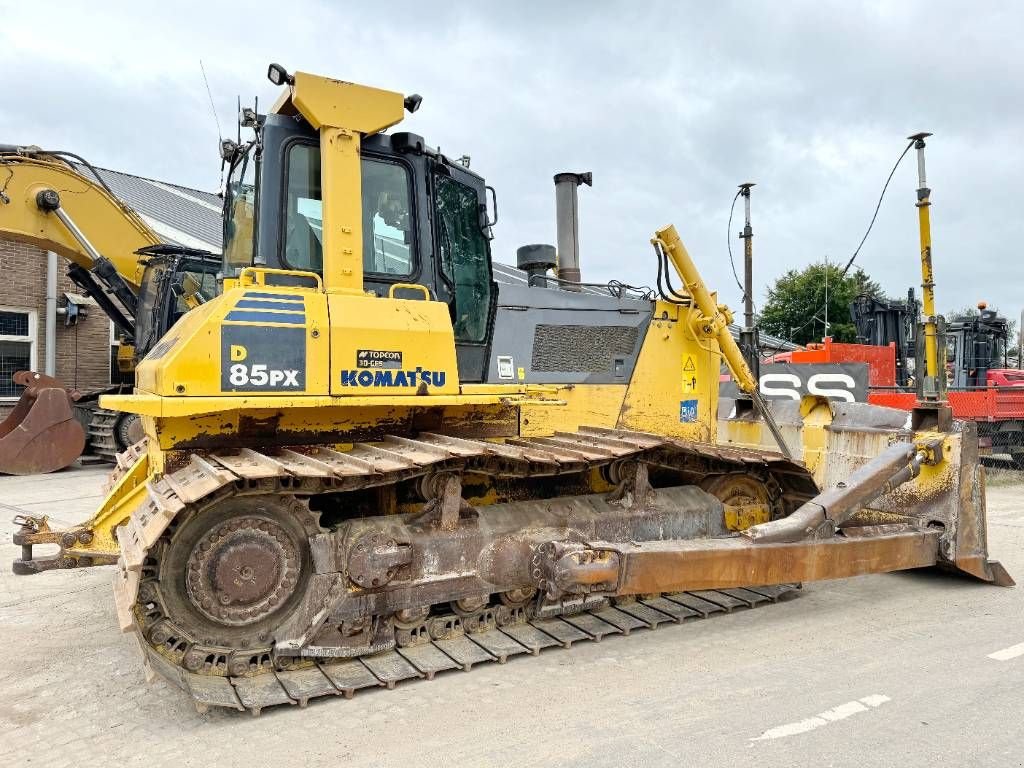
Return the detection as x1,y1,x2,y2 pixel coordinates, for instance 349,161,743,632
0,0,1024,325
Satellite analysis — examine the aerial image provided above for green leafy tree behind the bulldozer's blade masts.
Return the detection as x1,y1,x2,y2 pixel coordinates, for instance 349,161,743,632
761,261,885,344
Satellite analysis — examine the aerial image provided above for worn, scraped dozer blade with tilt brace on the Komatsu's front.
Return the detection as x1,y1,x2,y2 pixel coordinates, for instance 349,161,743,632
719,396,1014,586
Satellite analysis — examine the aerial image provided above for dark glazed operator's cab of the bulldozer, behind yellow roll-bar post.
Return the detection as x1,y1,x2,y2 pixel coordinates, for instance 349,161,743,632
223,114,498,382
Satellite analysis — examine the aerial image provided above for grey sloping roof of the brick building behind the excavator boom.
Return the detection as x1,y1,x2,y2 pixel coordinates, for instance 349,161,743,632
76,165,222,253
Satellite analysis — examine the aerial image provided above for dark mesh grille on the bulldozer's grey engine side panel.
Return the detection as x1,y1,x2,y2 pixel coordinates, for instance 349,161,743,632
531,326,638,373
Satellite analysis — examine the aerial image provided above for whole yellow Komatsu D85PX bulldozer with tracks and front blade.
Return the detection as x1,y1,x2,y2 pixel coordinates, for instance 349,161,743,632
14,65,1012,713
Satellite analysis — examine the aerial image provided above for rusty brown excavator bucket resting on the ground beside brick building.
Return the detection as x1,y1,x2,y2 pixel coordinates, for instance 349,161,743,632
0,371,85,475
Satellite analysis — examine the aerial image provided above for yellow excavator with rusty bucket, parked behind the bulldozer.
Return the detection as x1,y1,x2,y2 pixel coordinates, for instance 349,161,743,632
0,144,220,474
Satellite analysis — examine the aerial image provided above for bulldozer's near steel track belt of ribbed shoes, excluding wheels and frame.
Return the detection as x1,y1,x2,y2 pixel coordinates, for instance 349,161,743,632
115,428,814,714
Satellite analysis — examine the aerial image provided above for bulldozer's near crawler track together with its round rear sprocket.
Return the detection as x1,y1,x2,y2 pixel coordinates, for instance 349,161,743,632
115,428,814,714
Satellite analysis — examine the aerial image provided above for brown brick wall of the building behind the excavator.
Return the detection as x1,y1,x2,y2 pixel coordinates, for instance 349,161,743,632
0,239,111,419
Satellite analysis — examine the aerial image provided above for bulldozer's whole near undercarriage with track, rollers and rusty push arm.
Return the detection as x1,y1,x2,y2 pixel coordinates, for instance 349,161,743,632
90,428,999,712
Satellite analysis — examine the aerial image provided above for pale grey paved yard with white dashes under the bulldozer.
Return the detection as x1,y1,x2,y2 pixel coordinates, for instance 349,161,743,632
0,469,1024,768
